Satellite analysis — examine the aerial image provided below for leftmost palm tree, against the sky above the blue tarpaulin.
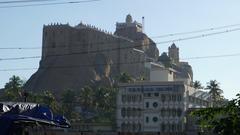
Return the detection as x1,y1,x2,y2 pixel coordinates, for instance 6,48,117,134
4,75,24,101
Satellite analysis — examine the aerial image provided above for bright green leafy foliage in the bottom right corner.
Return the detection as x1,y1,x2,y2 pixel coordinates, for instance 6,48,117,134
192,94,240,135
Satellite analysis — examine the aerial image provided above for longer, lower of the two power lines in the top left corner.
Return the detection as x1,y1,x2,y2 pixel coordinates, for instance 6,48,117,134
0,0,101,8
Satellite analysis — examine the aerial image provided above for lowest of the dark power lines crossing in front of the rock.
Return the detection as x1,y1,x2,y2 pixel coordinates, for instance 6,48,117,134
0,53,240,72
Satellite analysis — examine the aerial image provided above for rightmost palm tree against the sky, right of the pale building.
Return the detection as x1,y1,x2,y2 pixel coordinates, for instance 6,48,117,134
206,80,223,107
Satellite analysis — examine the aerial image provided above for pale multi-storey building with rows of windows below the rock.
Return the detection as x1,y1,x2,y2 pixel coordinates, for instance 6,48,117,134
117,81,206,134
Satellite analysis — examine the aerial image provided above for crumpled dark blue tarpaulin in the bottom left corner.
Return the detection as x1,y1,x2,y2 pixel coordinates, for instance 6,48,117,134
0,102,70,135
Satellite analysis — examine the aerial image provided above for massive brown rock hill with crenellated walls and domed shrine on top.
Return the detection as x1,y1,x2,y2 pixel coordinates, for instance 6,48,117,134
25,15,159,94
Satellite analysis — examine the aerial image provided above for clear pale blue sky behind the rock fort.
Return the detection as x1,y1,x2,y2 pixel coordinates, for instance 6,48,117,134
0,0,240,99
